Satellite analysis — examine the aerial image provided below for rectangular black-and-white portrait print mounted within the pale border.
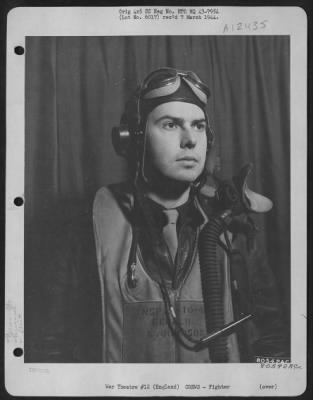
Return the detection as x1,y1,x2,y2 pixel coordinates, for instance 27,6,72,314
24,35,292,364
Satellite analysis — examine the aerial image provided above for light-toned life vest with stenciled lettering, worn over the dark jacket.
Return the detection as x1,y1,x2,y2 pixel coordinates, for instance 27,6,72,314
93,187,240,363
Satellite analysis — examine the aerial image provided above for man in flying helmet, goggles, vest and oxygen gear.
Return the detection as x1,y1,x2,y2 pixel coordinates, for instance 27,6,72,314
93,68,287,363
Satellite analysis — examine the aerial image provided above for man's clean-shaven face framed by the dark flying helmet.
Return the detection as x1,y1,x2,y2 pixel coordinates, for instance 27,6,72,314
145,101,207,183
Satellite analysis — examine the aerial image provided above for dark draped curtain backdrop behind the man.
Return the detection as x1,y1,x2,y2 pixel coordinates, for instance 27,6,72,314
25,36,290,362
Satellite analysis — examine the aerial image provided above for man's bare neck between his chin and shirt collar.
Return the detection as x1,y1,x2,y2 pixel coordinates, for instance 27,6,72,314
146,180,190,208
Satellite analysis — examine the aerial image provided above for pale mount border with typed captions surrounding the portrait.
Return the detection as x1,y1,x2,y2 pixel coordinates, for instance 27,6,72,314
5,6,307,396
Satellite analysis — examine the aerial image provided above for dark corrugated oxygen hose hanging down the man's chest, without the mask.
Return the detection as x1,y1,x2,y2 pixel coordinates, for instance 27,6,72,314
199,217,228,363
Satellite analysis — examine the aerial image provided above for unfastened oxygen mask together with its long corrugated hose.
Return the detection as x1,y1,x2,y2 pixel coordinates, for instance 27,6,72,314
199,163,272,363
